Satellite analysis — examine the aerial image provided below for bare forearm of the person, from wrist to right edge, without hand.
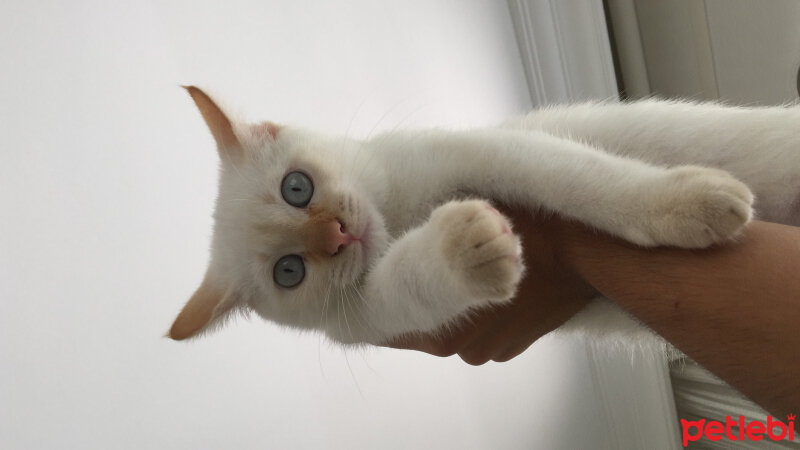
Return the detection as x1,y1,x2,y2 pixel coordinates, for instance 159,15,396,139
562,216,800,414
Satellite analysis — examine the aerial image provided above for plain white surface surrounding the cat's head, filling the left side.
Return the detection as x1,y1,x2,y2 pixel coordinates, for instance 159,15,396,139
0,0,604,449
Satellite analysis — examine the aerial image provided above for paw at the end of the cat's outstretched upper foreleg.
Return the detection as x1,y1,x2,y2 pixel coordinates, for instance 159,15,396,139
640,166,753,248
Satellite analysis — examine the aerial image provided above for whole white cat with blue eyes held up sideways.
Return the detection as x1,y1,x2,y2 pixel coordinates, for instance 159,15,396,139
169,87,800,344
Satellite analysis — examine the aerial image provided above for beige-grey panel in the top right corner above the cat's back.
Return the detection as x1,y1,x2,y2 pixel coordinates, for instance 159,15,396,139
609,0,800,105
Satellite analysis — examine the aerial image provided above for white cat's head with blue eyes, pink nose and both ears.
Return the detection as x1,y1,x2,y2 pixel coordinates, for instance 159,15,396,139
169,86,388,340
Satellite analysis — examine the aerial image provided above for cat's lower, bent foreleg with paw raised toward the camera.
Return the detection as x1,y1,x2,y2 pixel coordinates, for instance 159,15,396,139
350,200,523,343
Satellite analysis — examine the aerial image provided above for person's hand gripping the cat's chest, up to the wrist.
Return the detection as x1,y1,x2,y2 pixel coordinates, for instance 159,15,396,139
387,206,597,365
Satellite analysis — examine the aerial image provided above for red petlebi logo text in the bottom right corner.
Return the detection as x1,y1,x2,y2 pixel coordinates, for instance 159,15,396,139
681,414,795,447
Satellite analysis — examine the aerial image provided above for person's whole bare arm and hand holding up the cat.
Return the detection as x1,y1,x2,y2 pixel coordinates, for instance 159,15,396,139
392,210,800,413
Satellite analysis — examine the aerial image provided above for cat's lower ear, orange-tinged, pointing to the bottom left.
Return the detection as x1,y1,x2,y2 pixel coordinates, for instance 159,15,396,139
168,274,236,341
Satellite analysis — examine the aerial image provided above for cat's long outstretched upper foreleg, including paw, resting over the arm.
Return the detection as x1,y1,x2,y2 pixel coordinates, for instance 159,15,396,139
378,129,753,248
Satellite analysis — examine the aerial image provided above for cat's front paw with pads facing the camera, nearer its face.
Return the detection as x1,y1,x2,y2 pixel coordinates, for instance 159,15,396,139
431,200,524,302
